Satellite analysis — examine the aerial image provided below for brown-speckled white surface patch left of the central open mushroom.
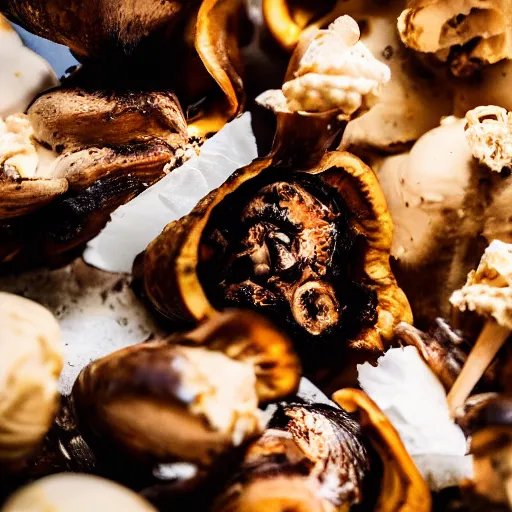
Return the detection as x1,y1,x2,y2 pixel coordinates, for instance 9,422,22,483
0,259,162,394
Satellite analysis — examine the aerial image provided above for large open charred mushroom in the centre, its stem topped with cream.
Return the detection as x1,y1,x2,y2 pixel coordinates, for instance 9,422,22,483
138,17,410,376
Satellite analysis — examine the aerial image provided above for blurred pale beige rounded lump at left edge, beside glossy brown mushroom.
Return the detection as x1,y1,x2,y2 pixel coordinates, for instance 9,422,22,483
0,292,63,463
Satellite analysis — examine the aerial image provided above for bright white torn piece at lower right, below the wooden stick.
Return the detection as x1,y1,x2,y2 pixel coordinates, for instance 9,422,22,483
357,347,473,490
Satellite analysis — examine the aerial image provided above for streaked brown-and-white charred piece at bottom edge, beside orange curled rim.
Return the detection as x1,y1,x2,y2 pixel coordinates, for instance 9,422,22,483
214,404,379,512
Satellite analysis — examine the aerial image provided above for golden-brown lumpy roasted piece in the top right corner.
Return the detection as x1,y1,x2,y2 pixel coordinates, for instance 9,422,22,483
398,0,512,76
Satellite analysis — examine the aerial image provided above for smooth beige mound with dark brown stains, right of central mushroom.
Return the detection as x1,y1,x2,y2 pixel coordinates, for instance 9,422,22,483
374,107,512,327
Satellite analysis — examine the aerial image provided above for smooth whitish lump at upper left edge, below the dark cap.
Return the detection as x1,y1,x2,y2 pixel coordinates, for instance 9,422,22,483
0,14,59,117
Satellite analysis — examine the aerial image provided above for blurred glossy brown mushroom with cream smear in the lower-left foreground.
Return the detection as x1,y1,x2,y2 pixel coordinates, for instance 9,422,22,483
73,312,300,467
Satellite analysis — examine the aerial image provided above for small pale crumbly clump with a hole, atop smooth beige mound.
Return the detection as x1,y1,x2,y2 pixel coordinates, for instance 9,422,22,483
464,105,512,172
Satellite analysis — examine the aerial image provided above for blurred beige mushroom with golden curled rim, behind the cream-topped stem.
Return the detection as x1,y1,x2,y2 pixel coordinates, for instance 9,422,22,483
263,0,453,155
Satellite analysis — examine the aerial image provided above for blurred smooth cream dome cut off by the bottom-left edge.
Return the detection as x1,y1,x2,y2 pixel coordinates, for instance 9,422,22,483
1,473,157,512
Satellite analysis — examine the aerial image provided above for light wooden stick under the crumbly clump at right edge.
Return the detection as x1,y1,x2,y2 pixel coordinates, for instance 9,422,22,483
448,320,510,415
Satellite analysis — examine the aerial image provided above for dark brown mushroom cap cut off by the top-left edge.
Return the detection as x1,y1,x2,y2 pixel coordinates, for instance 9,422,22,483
0,0,201,61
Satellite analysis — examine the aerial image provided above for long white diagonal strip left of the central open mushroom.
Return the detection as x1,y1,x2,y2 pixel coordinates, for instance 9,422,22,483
84,113,258,272
